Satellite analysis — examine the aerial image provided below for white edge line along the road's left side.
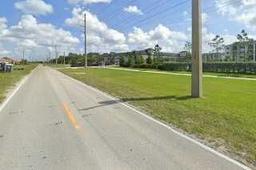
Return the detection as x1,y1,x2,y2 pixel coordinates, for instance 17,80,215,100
0,65,36,112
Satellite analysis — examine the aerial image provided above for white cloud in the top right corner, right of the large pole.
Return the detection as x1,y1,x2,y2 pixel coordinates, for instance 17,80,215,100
216,0,256,30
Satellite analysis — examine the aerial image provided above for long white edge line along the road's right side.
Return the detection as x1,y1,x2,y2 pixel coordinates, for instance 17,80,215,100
59,68,251,170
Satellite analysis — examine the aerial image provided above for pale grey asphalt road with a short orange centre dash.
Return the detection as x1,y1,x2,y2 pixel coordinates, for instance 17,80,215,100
0,66,249,170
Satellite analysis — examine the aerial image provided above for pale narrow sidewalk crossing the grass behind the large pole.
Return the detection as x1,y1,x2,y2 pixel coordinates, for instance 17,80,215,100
107,67,256,81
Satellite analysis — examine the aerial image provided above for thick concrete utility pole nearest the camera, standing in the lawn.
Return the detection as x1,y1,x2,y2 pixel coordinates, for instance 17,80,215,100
191,0,203,98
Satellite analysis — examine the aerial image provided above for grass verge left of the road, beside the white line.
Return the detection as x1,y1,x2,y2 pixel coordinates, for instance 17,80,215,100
0,64,36,103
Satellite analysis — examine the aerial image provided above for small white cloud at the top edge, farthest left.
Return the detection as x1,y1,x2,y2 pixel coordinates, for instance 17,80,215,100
15,0,53,15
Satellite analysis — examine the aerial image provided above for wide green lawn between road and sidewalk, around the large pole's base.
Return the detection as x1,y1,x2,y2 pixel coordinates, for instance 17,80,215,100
61,69,256,165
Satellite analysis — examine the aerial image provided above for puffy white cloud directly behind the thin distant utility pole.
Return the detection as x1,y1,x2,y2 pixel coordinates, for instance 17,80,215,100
65,8,128,52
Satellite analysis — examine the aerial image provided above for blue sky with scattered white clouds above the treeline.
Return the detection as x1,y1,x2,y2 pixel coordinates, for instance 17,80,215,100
0,0,256,60
